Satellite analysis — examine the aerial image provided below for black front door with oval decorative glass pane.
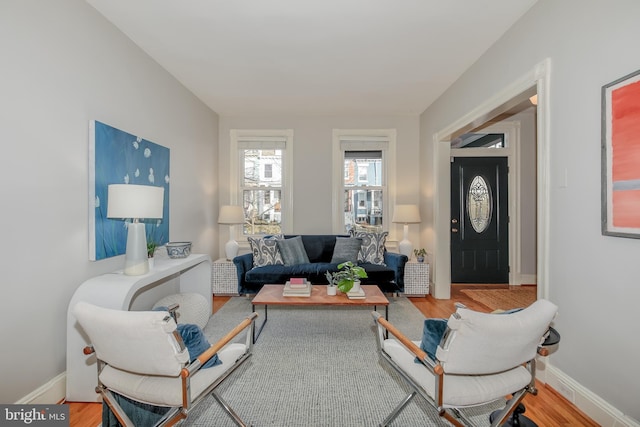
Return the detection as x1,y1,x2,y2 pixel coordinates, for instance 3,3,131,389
451,157,509,283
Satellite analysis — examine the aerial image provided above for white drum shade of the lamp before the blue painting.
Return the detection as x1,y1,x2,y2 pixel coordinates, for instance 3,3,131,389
107,184,164,219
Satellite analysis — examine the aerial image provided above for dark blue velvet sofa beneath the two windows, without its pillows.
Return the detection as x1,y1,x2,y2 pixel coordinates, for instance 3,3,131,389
233,234,409,295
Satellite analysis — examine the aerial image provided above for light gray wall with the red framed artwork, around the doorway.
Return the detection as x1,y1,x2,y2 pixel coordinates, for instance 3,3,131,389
420,0,640,422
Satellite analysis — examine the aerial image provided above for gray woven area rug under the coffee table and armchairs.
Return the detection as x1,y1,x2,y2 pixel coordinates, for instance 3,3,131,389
185,297,500,427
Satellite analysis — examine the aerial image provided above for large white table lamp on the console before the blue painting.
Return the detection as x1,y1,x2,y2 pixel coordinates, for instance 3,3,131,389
107,184,164,276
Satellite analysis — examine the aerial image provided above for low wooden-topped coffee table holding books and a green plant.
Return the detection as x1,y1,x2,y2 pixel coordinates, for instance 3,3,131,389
251,285,389,343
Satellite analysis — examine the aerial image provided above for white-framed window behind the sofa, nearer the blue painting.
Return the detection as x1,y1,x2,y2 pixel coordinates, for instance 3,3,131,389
231,130,293,235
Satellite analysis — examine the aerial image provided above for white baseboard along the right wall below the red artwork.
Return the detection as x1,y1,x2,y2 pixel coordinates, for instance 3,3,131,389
543,365,640,427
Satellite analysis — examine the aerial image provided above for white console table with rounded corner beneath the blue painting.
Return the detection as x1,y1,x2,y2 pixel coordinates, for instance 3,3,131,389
66,254,212,402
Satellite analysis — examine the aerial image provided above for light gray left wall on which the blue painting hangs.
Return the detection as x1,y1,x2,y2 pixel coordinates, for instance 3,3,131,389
0,0,218,403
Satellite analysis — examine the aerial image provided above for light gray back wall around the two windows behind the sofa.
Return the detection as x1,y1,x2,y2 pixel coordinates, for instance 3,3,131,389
219,116,420,251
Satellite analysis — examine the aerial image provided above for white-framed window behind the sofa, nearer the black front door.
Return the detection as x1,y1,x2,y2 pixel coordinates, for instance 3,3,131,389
334,130,395,233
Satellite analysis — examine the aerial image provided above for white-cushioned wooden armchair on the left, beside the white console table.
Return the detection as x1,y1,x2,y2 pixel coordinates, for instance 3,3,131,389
74,302,257,426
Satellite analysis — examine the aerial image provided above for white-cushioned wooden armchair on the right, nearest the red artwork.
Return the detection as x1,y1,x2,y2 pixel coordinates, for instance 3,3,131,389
372,299,558,426
